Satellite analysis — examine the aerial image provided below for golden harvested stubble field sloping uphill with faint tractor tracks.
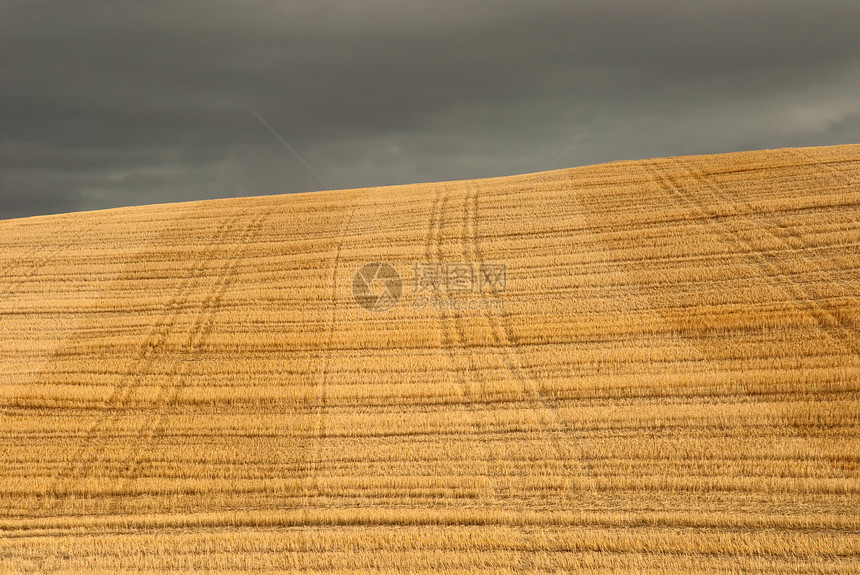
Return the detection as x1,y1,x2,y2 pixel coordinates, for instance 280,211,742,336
0,146,860,574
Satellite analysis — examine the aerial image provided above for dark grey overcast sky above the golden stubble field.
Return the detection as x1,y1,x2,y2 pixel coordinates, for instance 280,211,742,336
0,0,860,218
